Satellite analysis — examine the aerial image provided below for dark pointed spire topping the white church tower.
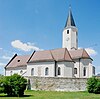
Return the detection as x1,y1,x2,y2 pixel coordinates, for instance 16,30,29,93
65,6,75,27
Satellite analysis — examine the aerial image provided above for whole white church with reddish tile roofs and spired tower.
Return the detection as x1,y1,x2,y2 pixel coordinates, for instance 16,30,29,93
5,8,95,78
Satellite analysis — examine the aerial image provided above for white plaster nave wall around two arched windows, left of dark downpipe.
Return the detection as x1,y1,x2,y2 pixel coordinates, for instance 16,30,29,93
27,62,55,77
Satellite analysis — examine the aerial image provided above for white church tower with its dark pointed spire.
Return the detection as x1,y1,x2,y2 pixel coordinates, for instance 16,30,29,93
62,7,78,50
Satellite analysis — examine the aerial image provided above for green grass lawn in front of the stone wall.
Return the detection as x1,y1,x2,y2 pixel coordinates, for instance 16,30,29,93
0,91,100,99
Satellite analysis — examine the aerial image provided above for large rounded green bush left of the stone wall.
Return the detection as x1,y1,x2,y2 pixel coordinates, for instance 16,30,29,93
1,74,27,96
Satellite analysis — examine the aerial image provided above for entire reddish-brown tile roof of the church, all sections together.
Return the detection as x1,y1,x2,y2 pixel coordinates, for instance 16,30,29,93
5,48,91,68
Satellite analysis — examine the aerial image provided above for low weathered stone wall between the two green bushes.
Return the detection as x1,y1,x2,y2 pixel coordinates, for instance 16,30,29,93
27,77,87,91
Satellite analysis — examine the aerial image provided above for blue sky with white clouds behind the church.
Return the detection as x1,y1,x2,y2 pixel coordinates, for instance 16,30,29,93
0,0,100,74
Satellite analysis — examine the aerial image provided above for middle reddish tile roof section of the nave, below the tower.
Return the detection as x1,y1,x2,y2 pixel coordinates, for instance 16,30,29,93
29,48,72,62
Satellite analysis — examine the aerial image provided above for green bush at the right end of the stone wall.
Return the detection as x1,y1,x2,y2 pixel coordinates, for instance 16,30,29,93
87,77,100,93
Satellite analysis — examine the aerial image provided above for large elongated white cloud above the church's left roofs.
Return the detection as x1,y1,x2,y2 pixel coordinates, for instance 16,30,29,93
11,40,42,51
